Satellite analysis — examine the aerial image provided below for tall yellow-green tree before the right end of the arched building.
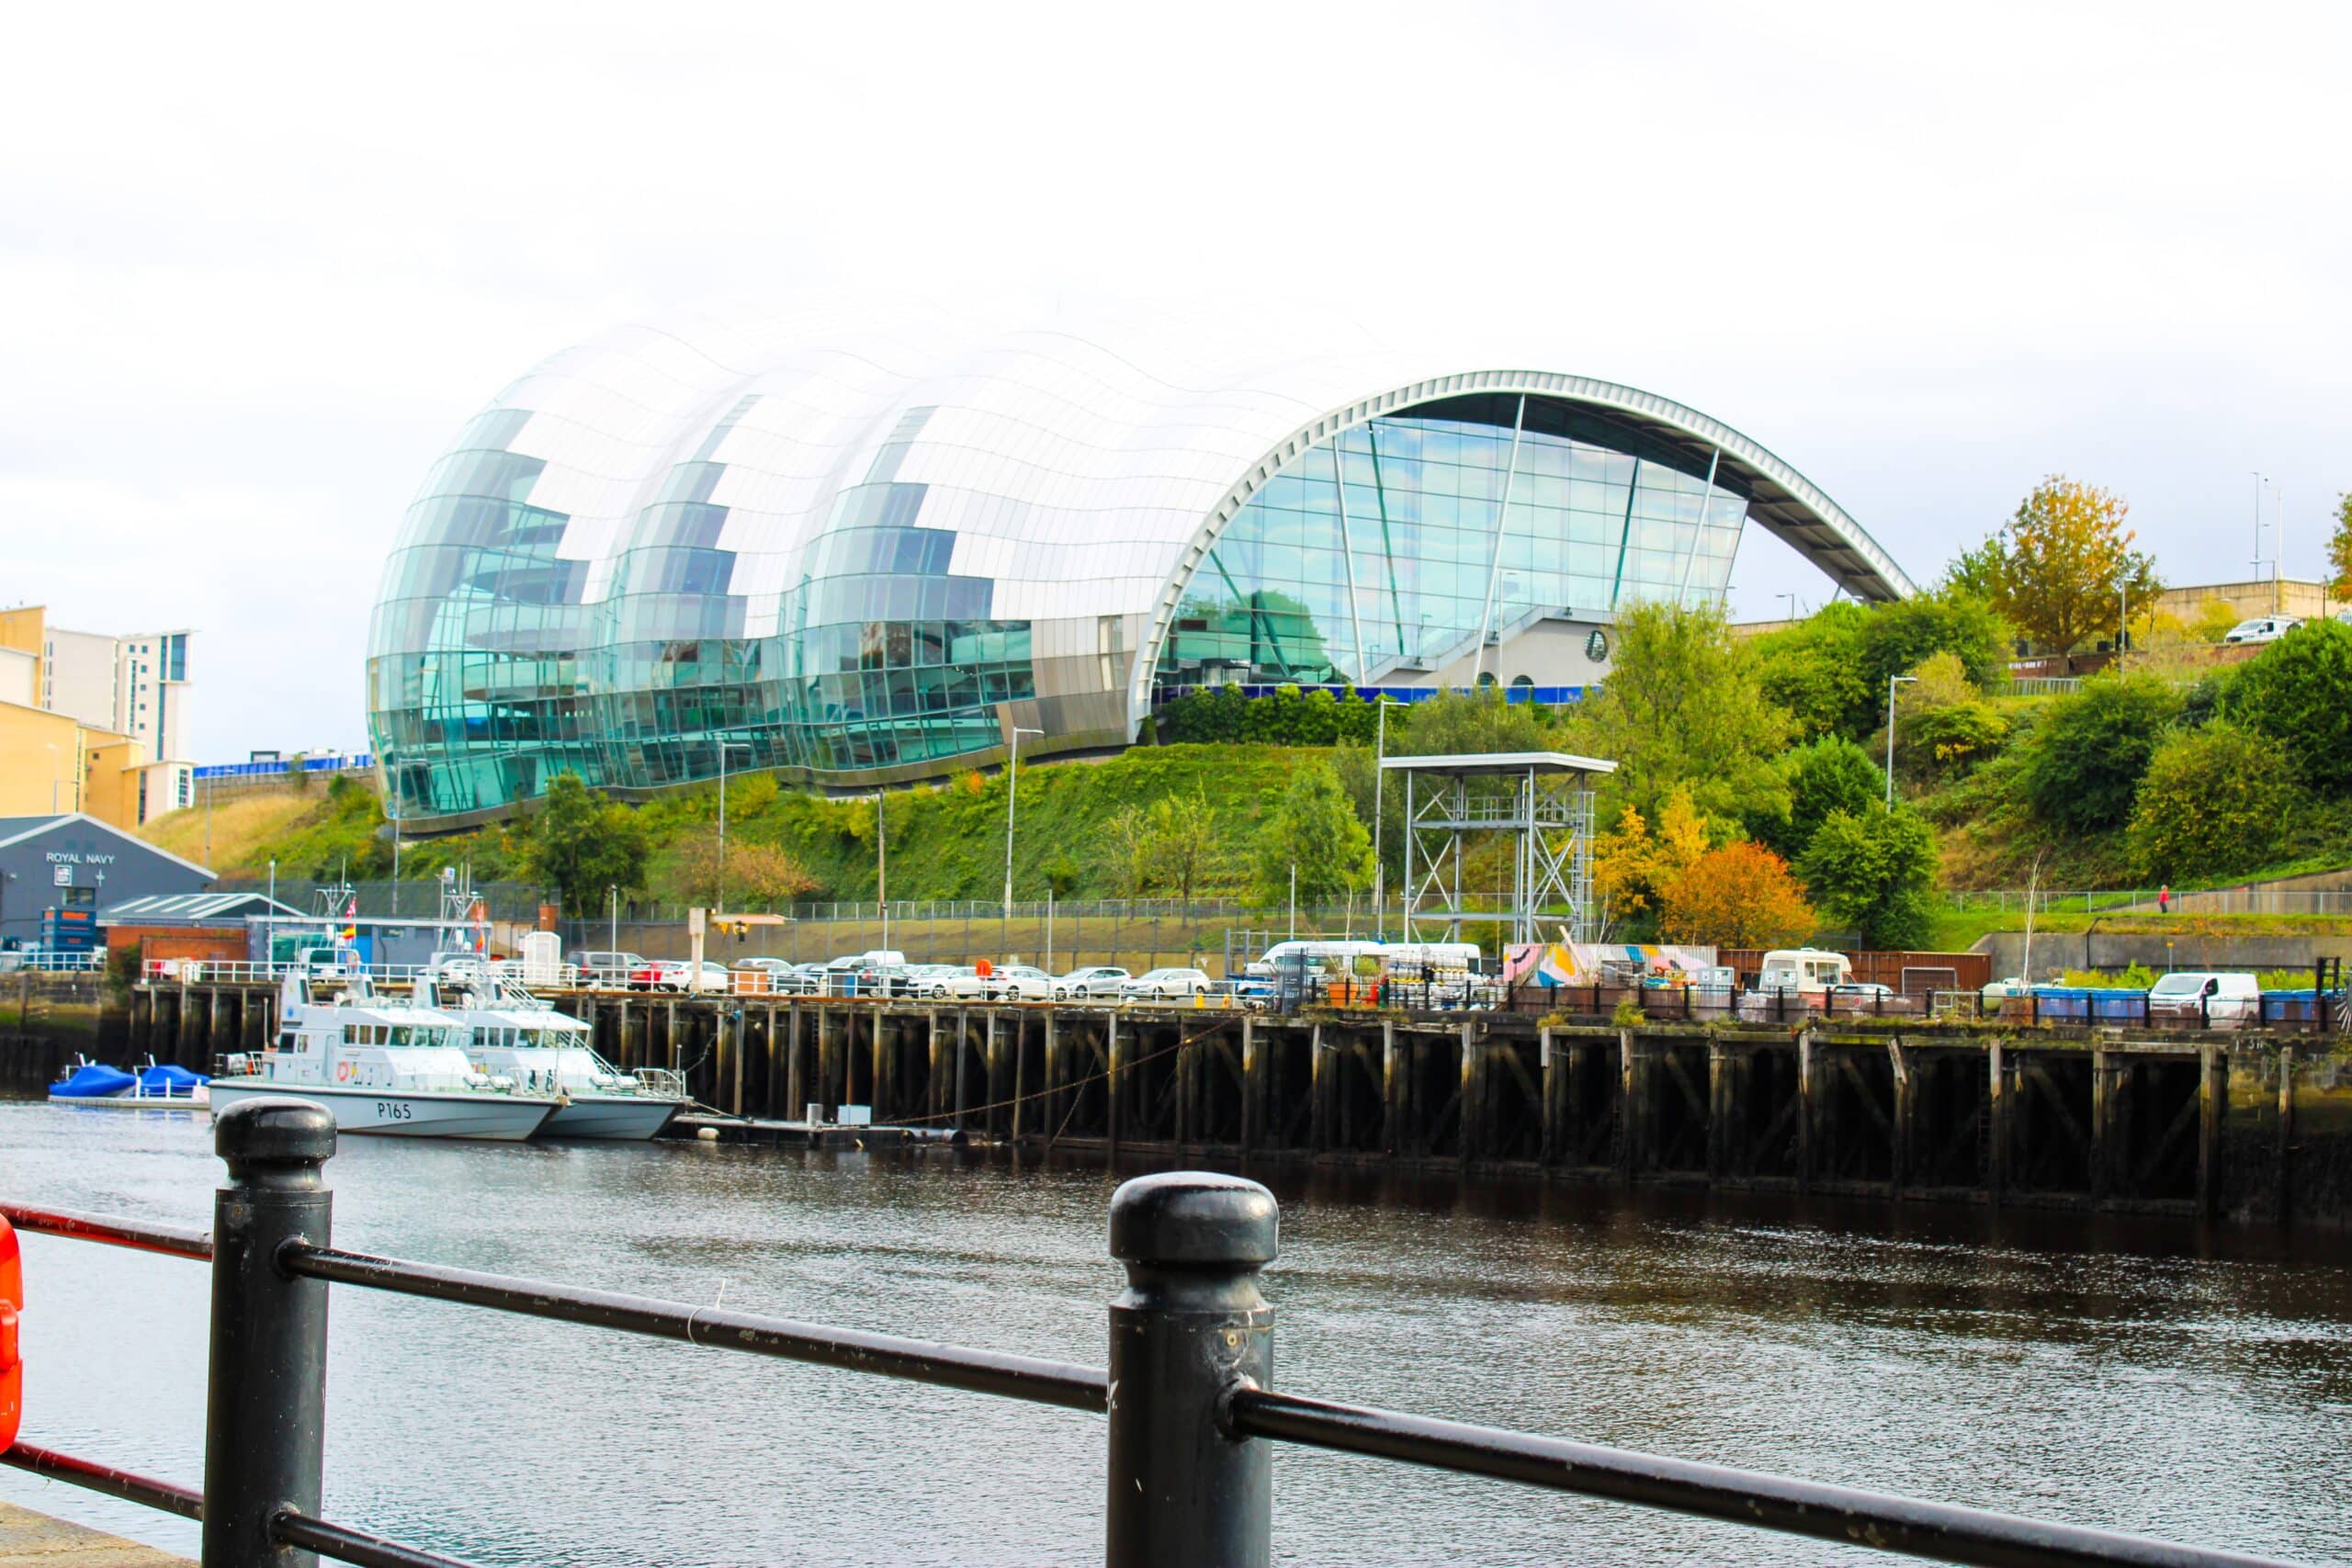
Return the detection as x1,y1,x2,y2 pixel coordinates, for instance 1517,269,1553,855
1569,602,1797,823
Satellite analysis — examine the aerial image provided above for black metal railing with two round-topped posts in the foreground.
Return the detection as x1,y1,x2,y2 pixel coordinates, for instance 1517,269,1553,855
0,1100,2314,1568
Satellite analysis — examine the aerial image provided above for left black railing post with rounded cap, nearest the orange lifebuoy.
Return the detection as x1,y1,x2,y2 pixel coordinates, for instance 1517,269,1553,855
202,1100,334,1568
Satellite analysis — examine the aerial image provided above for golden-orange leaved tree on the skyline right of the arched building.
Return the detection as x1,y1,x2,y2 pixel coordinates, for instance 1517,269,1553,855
1962,475,2164,653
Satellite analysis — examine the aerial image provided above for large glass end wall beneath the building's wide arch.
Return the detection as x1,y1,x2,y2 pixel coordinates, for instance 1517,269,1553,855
1158,398,1747,686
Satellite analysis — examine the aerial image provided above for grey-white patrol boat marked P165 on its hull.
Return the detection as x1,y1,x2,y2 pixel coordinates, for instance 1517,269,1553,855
209,964,558,1143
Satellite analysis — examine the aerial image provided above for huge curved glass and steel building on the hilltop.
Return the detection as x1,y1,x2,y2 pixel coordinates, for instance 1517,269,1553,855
367,310,1910,828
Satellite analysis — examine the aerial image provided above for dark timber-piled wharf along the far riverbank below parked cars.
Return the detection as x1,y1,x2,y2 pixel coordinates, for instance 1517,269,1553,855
110,978,2352,1224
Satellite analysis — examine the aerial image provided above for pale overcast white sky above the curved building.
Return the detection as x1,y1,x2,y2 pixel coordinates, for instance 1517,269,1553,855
0,0,2352,761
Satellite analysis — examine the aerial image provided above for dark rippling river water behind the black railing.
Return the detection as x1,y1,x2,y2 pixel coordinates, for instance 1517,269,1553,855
0,1102,2352,1565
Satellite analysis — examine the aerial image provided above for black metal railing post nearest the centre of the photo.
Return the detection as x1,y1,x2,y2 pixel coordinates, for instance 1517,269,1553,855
1103,1170,1277,1568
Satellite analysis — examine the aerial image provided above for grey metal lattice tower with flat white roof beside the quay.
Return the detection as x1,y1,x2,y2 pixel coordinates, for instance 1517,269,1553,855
1381,752,1616,942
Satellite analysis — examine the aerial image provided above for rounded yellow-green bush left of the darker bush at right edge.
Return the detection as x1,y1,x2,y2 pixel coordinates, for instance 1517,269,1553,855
2129,724,2296,882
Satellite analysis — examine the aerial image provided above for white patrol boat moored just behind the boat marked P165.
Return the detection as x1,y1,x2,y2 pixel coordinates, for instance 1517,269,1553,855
419,962,687,1140
